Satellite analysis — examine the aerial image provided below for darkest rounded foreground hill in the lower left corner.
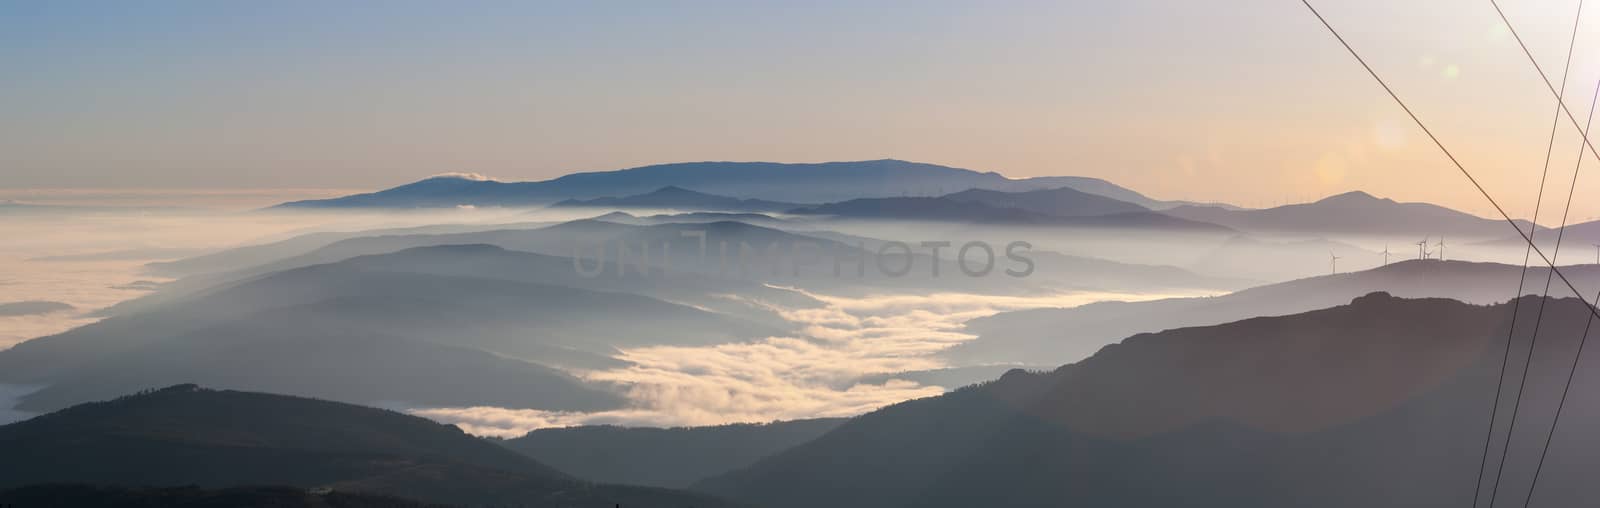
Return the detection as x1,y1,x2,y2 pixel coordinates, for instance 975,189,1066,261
0,385,742,506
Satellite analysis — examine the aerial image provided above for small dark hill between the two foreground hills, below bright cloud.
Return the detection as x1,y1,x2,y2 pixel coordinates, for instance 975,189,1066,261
502,419,845,489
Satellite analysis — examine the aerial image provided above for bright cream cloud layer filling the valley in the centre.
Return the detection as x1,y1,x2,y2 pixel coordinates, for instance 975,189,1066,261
411,287,1190,436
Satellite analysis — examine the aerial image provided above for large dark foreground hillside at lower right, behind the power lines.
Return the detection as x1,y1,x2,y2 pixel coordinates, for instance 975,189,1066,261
696,294,1600,508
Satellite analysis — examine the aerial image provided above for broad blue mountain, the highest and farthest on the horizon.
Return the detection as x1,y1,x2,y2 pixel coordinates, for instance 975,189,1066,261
278,160,1177,208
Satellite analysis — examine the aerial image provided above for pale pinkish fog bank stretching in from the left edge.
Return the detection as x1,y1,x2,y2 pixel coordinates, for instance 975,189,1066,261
0,201,569,350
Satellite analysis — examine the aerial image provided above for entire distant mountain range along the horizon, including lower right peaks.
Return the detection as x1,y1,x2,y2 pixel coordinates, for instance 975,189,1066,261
259,160,1531,252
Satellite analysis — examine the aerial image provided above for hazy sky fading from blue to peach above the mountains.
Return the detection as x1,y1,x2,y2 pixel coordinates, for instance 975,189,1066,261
0,0,1600,219
